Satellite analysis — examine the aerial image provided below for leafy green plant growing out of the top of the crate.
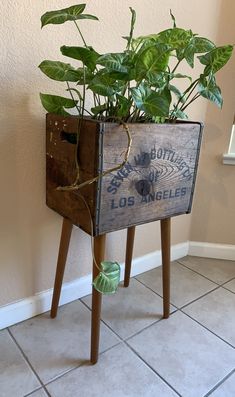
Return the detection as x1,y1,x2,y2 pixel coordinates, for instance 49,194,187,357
39,4,233,123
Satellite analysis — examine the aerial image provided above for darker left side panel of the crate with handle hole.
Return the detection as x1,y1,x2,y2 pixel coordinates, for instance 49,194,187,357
46,114,99,233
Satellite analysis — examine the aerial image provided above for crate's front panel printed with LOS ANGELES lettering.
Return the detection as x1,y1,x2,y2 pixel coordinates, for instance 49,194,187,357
99,123,201,234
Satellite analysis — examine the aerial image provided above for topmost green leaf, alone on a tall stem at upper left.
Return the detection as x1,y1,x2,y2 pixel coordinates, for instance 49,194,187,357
41,4,98,28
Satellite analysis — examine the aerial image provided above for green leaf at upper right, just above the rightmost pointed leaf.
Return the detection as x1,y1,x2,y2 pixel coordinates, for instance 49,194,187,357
184,36,215,68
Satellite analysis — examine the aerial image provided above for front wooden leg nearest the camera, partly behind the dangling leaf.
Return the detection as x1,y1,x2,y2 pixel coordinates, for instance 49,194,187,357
91,234,106,364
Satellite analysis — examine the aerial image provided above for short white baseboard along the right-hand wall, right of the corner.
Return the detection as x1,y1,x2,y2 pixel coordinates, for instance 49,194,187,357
188,241,235,261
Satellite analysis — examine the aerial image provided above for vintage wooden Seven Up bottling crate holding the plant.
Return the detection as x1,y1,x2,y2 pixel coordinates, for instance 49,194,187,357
46,114,202,236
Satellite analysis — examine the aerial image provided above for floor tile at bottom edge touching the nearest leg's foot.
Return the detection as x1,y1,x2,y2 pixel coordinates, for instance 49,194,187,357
47,345,177,397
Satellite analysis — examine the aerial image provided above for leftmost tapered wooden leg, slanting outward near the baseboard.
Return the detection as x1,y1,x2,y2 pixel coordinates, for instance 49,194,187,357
51,218,73,318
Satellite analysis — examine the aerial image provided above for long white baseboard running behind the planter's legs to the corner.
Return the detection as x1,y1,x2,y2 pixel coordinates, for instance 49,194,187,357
0,242,189,329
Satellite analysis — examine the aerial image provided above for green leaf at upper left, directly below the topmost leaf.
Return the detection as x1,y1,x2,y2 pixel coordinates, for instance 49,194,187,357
60,45,100,71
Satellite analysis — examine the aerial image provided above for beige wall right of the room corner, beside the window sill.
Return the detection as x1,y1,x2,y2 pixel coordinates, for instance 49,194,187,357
190,0,235,244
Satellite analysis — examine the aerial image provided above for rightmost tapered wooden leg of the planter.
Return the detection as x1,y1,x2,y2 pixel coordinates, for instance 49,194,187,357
161,218,171,318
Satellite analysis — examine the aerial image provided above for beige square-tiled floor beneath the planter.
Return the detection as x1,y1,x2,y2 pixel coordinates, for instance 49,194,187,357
0,257,235,397
